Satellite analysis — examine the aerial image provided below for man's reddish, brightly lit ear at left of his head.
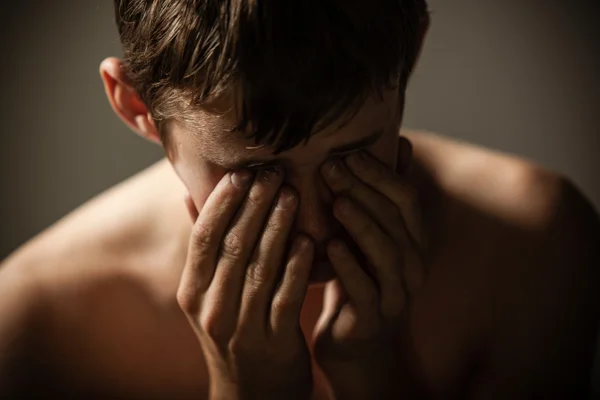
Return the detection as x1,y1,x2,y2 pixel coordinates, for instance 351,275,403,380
100,57,161,144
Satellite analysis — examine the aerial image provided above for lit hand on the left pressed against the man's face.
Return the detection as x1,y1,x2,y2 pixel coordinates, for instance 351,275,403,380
177,168,314,399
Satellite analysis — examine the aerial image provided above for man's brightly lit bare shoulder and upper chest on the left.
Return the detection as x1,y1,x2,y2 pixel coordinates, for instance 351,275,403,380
0,161,203,398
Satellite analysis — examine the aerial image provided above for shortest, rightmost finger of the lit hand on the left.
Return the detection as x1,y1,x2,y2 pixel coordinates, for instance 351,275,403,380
270,235,314,334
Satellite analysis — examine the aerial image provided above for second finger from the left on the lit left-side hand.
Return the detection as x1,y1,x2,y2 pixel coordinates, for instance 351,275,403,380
207,168,283,320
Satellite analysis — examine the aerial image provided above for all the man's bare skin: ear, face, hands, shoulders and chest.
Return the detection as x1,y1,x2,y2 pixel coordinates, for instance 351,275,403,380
0,22,599,399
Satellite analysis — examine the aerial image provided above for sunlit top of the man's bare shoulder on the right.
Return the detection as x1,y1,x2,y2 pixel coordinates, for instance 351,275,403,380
403,131,574,223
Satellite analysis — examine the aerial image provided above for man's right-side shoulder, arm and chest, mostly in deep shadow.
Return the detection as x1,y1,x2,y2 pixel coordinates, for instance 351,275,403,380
403,132,600,399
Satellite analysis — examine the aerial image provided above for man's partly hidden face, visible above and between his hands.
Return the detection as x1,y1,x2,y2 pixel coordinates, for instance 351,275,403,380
166,90,404,281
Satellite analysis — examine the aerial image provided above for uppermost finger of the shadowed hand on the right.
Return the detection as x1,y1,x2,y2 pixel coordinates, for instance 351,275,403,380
345,151,423,248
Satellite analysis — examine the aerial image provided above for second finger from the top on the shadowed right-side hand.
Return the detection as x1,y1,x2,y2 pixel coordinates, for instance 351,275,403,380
321,160,405,245
